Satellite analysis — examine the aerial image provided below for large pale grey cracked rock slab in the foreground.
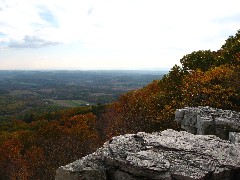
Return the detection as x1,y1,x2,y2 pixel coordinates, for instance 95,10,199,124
56,130,240,180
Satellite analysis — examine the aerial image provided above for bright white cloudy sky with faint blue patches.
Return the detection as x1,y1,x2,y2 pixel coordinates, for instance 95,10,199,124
0,0,240,70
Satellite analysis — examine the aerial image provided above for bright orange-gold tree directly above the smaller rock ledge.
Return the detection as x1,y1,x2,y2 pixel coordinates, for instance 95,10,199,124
182,65,240,109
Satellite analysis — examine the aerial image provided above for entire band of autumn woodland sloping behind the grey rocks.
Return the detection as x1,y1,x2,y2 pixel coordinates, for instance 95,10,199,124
0,31,240,179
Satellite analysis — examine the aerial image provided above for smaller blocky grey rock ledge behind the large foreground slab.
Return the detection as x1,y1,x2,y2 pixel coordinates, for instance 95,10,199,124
175,107,240,143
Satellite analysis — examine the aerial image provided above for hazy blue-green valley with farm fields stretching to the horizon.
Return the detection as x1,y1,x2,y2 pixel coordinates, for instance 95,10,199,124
0,71,167,121
